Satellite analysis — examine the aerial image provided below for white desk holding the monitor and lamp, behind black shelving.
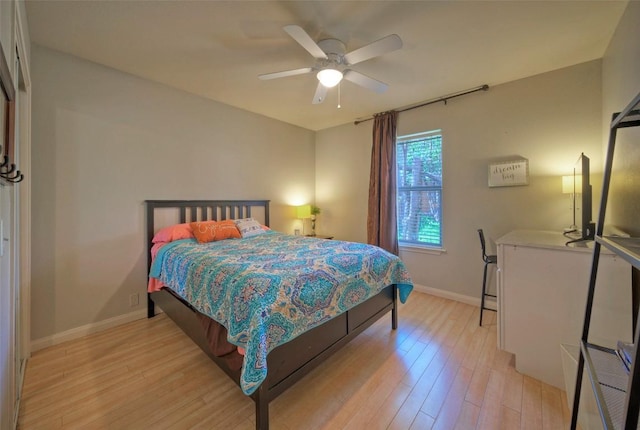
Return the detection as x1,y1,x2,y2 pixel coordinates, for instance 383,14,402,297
496,230,632,390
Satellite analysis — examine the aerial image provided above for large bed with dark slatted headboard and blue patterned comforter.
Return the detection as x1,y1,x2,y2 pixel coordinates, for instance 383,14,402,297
146,200,412,430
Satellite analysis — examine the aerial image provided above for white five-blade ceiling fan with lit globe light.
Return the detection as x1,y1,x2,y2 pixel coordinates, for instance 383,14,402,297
258,25,402,104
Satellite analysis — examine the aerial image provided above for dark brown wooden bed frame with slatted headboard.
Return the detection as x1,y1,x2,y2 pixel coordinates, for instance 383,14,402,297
146,200,398,430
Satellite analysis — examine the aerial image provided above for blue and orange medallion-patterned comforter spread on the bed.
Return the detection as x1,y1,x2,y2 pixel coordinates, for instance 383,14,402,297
150,231,413,395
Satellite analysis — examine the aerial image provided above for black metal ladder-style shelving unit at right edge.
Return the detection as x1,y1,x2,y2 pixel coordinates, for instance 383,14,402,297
571,90,640,430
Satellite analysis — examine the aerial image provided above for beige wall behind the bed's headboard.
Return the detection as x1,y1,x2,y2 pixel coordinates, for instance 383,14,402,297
31,46,315,346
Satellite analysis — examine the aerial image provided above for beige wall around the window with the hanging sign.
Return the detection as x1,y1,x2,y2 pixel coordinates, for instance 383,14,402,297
316,61,602,297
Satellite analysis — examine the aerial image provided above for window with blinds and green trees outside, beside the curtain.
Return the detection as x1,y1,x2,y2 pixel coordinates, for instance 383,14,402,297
396,130,442,247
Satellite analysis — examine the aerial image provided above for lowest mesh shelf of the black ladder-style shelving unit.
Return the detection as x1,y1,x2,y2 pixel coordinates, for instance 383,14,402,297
581,342,629,429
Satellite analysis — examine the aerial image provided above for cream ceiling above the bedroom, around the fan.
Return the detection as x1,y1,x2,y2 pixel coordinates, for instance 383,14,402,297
26,0,627,130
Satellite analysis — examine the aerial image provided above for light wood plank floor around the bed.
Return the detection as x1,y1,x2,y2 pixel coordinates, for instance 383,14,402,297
19,292,570,430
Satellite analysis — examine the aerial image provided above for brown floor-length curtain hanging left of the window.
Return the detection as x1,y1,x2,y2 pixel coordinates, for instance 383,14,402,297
367,111,398,255
